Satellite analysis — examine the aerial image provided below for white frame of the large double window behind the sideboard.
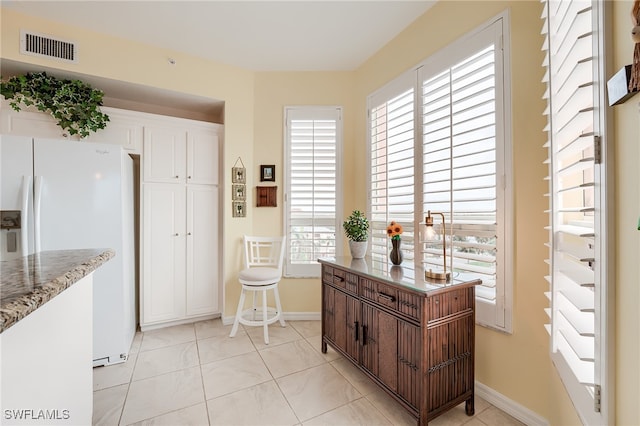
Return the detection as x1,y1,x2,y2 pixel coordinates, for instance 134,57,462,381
367,10,514,333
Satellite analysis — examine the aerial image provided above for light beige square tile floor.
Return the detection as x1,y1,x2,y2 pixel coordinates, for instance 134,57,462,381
93,319,522,426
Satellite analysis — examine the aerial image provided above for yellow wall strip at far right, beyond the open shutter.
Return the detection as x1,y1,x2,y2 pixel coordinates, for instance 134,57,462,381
610,1,640,426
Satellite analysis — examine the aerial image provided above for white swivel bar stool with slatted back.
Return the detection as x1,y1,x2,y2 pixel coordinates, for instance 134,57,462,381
229,235,286,345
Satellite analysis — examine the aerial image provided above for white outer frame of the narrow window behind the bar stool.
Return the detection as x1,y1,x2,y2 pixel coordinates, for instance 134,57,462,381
283,105,344,278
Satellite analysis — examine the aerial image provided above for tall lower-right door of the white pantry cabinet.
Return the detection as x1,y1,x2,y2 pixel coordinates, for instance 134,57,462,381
186,185,220,316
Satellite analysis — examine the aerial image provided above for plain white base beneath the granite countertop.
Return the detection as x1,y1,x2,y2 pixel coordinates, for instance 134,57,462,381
0,274,93,426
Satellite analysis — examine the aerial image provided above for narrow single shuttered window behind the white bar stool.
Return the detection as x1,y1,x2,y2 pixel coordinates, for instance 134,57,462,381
285,107,342,277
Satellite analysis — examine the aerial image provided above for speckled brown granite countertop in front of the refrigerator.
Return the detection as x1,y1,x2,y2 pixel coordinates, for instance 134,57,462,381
0,249,115,333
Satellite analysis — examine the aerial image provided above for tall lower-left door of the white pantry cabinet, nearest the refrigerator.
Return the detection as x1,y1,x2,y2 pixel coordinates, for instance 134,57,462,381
141,184,186,325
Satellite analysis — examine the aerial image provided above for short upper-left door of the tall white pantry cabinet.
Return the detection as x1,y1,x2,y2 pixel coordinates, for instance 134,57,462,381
142,126,187,183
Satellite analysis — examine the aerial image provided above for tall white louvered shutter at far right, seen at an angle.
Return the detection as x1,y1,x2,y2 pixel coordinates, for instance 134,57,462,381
542,0,613,424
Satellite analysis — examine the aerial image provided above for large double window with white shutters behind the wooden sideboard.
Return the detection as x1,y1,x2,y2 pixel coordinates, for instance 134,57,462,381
368,14,513,331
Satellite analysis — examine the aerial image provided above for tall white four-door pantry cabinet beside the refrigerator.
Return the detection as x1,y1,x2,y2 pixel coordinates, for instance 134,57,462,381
140,125,220,330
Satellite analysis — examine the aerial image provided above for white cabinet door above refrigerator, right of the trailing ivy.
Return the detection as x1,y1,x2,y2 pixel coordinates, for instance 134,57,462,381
84,108,144,154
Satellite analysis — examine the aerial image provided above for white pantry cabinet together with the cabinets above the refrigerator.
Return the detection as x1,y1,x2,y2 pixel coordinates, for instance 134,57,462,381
0,101,223,330
